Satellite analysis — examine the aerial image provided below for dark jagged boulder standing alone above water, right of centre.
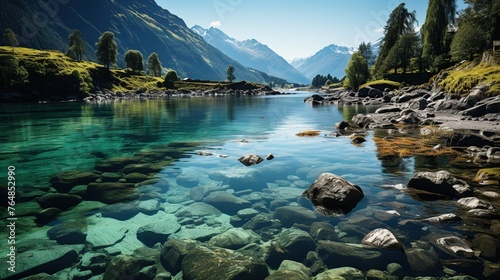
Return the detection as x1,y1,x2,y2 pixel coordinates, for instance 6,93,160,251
302,173,364,216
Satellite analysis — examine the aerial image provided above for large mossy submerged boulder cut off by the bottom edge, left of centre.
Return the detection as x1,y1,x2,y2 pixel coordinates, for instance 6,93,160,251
181,246,269,280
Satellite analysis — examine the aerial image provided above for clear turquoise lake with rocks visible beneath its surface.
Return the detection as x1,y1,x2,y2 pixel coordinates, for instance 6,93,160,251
0,92,500,278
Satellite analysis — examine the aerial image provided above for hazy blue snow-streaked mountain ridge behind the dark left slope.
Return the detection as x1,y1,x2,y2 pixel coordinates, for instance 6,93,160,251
191,25,310,84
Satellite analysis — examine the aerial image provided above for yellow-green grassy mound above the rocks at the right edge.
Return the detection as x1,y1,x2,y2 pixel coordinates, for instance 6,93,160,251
439,62,500,95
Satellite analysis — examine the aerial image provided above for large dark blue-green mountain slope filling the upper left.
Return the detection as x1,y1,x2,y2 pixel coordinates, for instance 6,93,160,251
0,0,265,82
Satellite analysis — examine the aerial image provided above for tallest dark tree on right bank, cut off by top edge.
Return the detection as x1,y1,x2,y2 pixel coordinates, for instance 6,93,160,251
422,0,457,60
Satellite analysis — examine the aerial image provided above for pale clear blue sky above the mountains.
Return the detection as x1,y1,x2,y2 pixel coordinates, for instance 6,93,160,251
156,0,465,60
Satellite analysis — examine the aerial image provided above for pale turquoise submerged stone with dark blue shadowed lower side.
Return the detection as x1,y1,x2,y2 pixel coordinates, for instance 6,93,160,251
136,218,181,247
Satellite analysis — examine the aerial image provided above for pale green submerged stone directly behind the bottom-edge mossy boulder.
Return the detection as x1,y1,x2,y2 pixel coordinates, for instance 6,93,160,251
208,228,260,250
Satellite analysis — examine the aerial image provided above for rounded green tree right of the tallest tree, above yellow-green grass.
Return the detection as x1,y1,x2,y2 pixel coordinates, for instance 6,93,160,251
451,24,487,61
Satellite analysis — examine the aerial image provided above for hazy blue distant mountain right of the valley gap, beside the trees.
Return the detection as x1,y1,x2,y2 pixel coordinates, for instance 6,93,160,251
291,44,354,80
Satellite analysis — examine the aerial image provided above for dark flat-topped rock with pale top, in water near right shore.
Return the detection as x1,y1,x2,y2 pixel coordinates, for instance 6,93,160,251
408,170,473,197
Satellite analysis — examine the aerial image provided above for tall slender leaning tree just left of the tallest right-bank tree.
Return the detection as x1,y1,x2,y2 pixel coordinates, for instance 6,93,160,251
375,3,417,73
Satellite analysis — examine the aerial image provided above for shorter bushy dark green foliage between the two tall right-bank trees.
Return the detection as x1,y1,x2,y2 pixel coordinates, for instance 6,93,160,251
383,33,419,74
